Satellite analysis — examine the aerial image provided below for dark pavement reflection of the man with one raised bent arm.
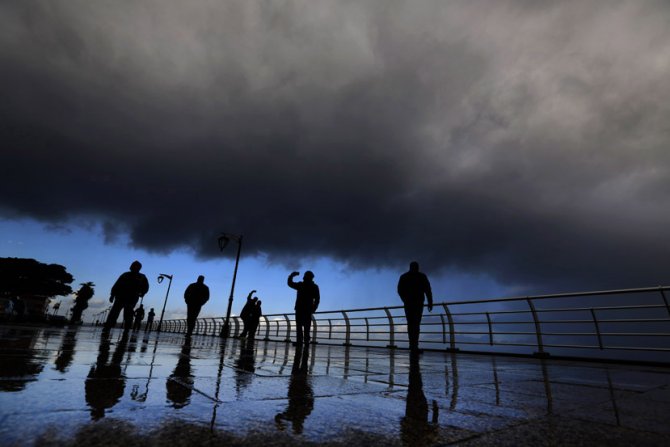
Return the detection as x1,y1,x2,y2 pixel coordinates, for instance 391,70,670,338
275,346,314,435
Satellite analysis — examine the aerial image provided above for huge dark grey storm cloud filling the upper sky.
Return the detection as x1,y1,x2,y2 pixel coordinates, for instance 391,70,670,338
0,0,670,289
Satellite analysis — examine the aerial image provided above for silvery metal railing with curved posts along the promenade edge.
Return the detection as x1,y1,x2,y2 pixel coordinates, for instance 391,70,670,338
159,287,670,362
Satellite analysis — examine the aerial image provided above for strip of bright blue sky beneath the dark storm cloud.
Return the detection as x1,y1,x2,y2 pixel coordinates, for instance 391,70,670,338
0,219,512,321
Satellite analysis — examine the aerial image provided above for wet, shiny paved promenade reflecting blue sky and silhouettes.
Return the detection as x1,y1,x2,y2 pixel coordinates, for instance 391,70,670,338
0,326,670,446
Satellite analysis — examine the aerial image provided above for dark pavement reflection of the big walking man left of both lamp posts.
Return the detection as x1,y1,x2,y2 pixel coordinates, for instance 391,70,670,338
84,331,128,420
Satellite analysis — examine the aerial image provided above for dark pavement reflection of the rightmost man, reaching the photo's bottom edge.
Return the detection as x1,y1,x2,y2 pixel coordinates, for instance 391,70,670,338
400,355,439,445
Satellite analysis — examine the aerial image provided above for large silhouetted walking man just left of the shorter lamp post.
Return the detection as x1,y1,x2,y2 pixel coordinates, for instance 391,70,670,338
105,261,149,331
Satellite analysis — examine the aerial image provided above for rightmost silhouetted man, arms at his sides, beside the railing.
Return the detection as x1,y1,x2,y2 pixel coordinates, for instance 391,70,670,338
398,261,433,352
